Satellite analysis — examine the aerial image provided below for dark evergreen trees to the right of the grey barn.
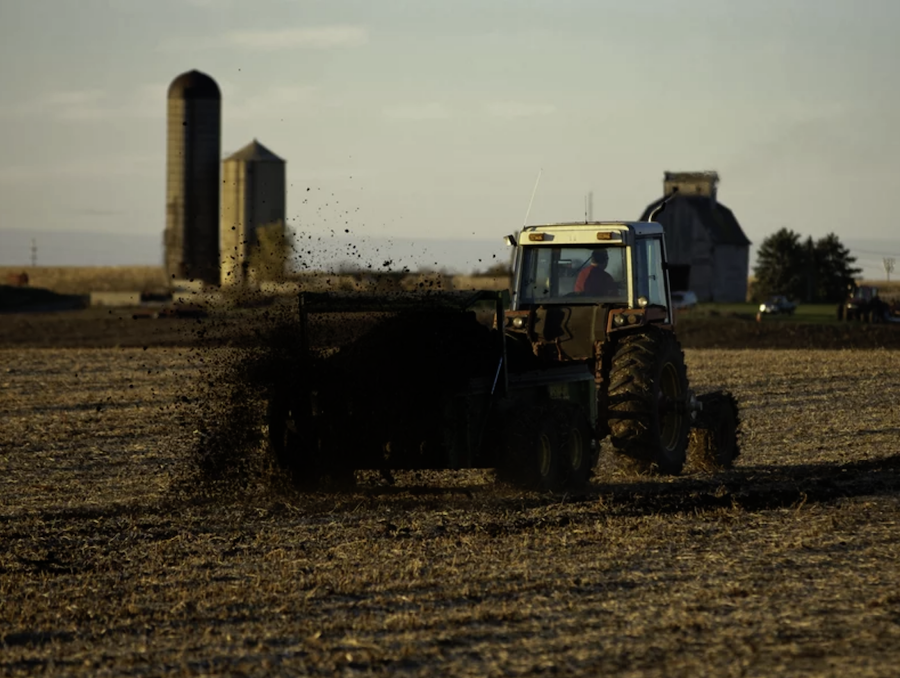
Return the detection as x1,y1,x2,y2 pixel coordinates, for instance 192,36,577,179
753,228,862,303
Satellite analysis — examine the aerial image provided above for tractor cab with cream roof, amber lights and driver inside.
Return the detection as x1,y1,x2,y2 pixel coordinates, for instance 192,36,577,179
505,221,674,361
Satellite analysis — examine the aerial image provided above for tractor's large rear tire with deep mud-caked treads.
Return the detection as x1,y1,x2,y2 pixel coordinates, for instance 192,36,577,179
609,327,690,475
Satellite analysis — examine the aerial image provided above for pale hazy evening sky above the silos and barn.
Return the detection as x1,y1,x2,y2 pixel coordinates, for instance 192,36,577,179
0,0,900,274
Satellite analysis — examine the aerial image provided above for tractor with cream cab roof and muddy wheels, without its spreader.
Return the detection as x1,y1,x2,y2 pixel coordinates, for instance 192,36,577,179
505,222,739,474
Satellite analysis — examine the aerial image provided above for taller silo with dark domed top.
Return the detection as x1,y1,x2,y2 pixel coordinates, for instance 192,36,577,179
165,71,222,285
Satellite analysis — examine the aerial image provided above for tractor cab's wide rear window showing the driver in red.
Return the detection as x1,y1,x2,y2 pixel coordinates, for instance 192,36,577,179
519,246,628,304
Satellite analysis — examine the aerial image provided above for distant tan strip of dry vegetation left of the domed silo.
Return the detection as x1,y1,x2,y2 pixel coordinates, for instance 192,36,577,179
0,266,167,294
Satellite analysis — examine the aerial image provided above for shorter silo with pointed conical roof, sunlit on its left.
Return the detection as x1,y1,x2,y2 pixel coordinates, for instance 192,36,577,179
221,139,286,285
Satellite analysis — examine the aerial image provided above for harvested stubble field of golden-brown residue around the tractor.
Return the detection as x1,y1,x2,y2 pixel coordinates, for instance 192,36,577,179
0,346,900,676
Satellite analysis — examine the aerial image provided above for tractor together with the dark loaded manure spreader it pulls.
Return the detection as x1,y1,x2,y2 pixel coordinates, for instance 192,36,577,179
268,215,740,491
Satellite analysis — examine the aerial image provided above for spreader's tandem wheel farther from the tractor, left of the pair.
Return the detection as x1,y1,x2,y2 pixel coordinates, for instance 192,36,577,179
500,405,564,492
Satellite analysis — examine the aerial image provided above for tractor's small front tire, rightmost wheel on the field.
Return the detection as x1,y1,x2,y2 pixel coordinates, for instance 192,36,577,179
688,391,741,473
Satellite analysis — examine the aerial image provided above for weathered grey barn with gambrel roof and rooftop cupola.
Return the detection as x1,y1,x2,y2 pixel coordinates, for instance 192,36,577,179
641,172,750,302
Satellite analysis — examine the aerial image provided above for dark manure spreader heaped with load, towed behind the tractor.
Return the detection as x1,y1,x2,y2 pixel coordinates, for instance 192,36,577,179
269,291,597,489
